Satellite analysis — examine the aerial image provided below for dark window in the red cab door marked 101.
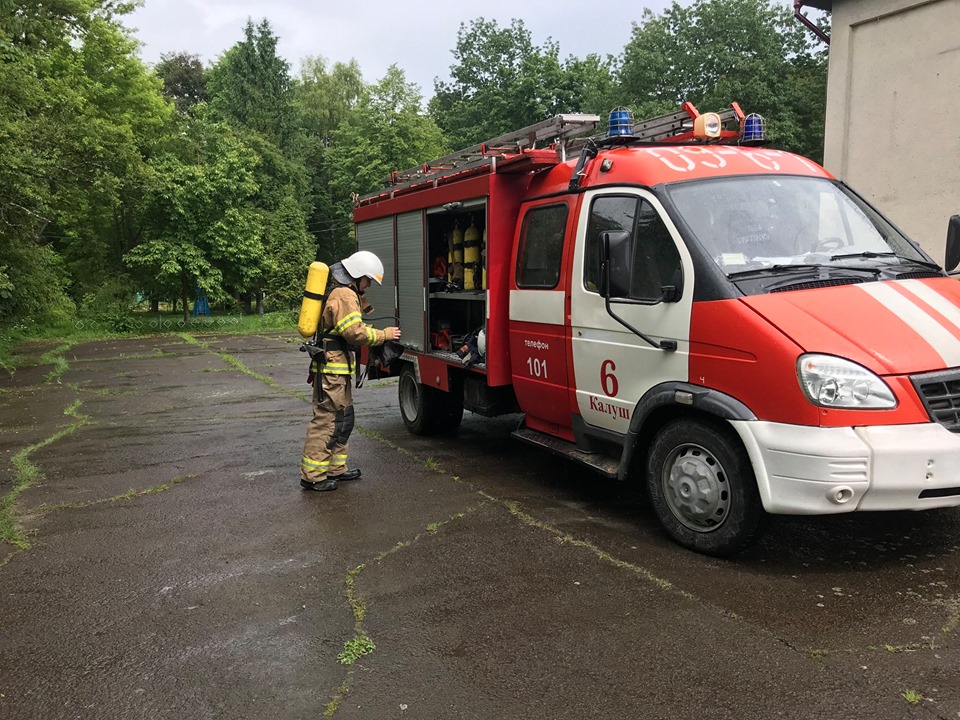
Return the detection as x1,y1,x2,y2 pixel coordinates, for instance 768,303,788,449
517,205,567,288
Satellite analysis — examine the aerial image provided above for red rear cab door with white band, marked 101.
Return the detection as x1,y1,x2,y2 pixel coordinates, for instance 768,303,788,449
509,200,572,439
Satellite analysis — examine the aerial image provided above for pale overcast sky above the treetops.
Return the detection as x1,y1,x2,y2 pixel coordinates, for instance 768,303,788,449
124,0,687,98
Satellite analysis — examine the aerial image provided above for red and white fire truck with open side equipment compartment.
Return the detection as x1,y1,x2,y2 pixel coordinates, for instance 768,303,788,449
353,103,960,556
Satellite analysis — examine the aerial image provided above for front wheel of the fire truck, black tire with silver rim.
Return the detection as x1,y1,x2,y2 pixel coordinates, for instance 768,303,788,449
646,419,768,557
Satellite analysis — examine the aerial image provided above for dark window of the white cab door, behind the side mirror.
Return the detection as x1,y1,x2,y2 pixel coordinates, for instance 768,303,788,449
583,195,682,301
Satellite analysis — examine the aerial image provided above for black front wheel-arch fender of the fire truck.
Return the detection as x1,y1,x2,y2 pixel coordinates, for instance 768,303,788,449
617,381,757,480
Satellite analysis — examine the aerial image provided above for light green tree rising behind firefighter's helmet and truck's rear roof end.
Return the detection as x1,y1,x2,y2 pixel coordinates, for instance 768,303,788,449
321,65,447,257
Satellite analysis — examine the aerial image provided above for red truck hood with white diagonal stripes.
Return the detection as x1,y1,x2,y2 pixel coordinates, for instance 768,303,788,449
742,277,960,375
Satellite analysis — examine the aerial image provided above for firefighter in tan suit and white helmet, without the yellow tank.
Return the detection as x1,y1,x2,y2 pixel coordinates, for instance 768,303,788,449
300,250,400,491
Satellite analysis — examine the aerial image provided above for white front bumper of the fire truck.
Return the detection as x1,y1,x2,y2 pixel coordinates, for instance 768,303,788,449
731,421,960,515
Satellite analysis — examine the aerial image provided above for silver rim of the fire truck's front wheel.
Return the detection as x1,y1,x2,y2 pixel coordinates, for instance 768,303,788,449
661,444,730,533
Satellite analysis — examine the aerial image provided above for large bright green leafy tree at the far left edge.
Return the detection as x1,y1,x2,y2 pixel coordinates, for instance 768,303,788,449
0,0,169,324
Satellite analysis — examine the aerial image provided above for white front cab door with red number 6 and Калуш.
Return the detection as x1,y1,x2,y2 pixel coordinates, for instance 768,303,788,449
570,188,693,433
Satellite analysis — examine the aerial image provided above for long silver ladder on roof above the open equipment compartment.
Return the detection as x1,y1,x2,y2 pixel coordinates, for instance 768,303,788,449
383,113,600,187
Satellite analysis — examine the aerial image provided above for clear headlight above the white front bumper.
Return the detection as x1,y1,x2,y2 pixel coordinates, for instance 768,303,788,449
797,353,897,410
